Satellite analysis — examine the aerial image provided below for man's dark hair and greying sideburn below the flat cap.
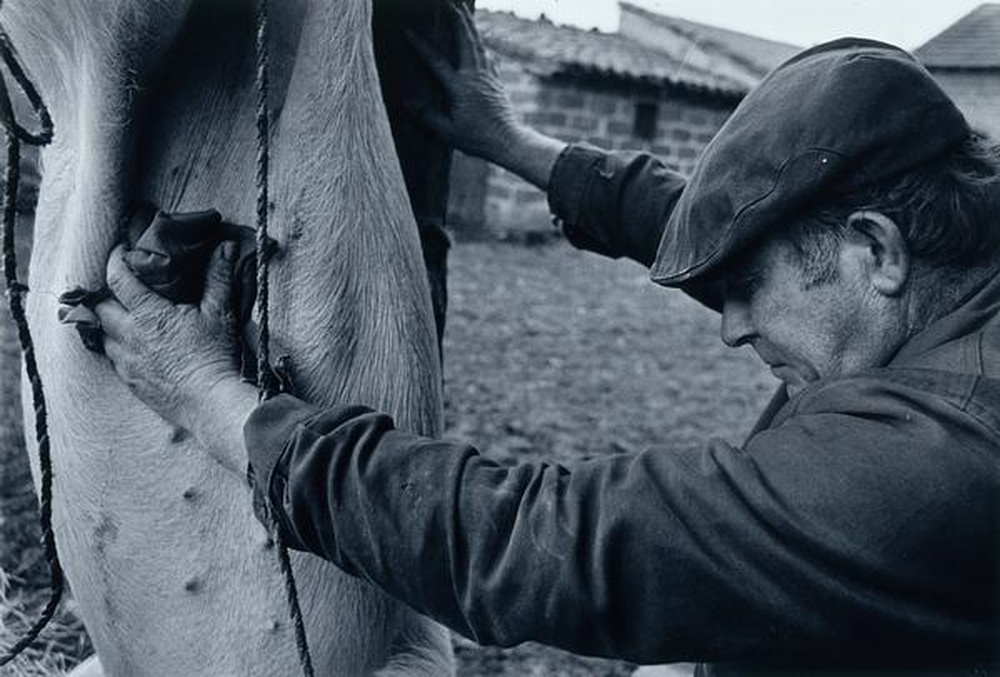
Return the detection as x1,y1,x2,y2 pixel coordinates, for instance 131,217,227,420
778,132,1000,287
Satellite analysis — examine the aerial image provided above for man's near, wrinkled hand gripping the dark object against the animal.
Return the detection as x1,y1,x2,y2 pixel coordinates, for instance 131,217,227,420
94,242,252,441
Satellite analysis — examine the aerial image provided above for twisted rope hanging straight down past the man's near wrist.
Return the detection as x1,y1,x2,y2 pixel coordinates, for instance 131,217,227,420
256,0,313,677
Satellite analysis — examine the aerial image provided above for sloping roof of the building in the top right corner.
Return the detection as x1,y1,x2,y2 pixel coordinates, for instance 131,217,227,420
914,3,1000,69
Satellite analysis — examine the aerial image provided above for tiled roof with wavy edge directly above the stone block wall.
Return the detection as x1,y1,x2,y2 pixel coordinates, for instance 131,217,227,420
475,10,749,99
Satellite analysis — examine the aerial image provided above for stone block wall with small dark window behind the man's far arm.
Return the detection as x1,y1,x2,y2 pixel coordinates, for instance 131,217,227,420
450,56,735,240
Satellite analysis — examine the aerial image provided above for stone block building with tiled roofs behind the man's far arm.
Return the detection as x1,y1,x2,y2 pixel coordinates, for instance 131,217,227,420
449,4,796,240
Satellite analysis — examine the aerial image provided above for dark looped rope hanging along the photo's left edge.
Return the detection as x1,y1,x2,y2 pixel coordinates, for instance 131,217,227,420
0,22,64,667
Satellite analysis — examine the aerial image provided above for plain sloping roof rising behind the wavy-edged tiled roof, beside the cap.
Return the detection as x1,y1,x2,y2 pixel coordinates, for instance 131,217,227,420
619,2,802,79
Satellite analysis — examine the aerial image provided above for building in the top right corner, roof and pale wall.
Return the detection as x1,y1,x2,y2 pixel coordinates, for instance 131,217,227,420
914,3,1000,139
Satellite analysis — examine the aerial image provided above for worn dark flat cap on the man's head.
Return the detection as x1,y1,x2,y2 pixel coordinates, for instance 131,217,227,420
651,38,970,290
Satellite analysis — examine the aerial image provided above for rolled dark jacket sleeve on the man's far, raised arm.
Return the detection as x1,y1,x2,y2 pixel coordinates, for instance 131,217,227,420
549,144,685,267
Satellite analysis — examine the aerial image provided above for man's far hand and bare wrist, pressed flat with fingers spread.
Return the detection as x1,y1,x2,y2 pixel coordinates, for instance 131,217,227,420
408,3,566,189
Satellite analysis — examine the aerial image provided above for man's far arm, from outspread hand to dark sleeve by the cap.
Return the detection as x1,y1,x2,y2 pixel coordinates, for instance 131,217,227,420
410,6,685,266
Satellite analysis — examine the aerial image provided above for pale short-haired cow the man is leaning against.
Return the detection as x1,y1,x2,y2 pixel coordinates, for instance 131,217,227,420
0,0,454,675
